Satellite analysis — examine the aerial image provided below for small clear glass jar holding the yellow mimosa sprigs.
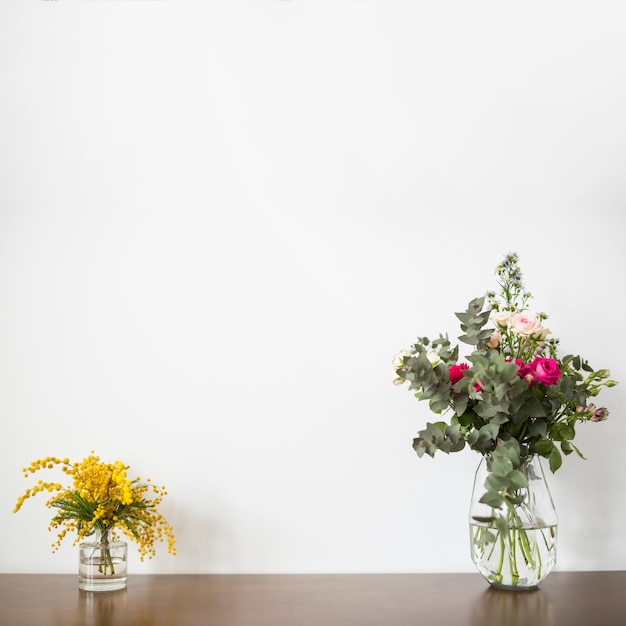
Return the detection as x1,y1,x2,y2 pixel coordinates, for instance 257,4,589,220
78,530,128,591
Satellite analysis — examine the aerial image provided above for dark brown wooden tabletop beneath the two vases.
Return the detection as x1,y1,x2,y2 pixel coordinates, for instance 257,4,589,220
0,571,626,626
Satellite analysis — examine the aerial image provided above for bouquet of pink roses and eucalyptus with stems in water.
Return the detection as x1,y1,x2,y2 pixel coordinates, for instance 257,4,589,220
393,254,617,580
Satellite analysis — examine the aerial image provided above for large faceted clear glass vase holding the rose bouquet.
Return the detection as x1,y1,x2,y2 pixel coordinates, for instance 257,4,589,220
469,455,558,591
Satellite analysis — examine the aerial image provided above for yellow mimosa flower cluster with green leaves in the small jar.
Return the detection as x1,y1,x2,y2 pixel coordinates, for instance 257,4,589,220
13,451,176,561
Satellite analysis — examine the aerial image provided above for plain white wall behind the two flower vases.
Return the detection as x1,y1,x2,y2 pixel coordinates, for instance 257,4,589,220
0,0,626,572
